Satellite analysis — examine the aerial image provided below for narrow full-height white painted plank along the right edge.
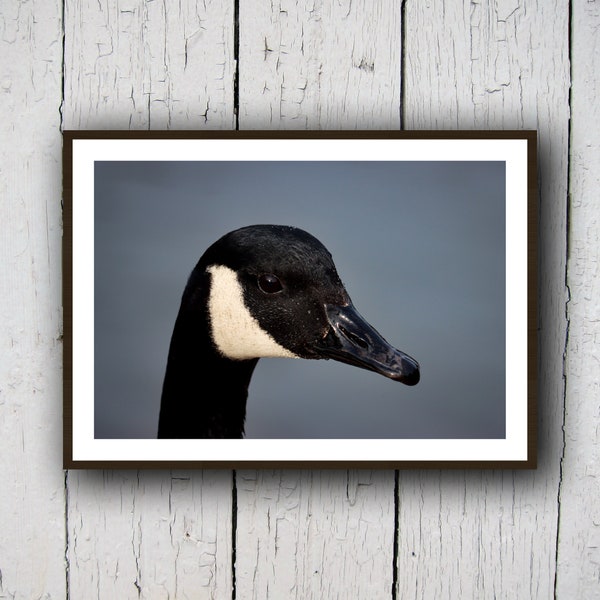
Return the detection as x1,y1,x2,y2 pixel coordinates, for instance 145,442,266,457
557,2,600,599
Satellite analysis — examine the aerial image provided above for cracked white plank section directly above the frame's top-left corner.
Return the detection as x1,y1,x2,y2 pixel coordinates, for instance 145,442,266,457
63,0,235,129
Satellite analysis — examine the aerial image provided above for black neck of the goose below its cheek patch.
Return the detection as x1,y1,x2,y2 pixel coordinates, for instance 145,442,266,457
158,290,258,438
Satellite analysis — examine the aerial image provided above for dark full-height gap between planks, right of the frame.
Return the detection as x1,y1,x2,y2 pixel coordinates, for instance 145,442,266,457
553,0,573,599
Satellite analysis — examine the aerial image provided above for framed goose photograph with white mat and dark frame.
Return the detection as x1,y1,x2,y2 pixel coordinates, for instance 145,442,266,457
63,131,538,469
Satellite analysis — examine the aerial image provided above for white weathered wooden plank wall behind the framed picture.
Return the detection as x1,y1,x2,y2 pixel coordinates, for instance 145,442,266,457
0,0,600,600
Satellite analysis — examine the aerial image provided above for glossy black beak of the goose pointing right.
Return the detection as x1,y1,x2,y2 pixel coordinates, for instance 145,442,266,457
314,304,420,385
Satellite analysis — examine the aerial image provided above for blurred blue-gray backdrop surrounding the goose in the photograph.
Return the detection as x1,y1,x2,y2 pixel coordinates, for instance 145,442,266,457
94,162,505,438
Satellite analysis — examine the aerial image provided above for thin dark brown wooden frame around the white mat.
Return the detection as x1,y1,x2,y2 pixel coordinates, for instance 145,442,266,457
62,130,539,469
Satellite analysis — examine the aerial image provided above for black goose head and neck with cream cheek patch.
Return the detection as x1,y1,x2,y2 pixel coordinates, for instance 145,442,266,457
158,225,419,438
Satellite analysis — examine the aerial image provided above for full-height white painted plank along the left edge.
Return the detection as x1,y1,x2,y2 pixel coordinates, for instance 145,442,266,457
0,1,66,599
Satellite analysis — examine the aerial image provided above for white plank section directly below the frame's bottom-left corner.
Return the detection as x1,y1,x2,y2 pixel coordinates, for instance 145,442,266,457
68,471,232,600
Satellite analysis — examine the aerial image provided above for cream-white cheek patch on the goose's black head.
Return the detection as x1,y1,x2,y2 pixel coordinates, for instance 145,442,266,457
207,265,299,360
